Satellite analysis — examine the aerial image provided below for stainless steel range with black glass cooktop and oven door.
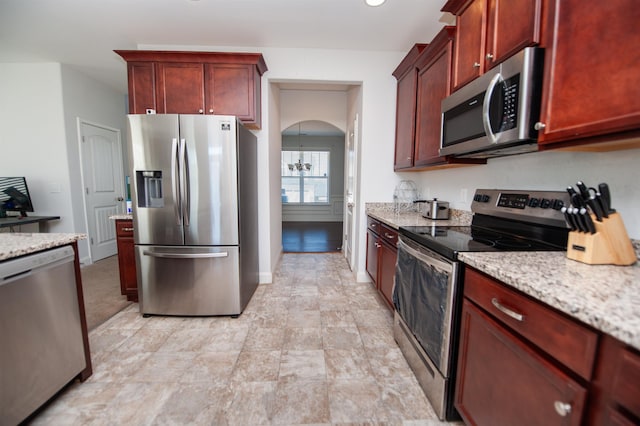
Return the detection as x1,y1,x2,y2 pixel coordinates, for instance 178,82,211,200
393,189,570,420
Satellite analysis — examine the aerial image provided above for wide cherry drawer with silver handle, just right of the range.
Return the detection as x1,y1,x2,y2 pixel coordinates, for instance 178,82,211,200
464,269,598,380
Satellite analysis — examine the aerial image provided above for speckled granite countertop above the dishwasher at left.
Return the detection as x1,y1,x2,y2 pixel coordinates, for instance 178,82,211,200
0,232,87,260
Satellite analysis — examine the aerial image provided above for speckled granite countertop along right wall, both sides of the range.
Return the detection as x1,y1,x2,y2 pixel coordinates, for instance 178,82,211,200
365,203,640,350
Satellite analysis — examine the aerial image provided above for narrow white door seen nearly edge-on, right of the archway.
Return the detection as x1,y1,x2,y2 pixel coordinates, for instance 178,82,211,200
344,115,358,270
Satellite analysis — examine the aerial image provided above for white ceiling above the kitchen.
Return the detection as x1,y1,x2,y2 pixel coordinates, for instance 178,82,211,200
0,0,451,93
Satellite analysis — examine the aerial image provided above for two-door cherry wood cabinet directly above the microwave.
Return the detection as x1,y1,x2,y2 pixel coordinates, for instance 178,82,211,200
442,0,542,90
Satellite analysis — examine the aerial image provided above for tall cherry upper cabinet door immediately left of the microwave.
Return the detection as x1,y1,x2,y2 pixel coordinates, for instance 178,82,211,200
414,43,451,166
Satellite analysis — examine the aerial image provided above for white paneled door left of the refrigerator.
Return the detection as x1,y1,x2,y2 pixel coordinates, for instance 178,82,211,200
80,122,125,262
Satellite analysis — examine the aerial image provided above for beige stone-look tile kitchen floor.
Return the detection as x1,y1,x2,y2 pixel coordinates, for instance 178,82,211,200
31,253,460,426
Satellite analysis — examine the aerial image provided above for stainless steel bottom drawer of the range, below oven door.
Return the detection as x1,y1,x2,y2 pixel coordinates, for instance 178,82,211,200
393,312,447,419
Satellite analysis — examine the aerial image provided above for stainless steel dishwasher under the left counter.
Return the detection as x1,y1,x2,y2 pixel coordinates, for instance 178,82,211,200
0,246,86,425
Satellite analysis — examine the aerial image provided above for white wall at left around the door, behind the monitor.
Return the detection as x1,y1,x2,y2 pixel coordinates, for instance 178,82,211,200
0,63,126,262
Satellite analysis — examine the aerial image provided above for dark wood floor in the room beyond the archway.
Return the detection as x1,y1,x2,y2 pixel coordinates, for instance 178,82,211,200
282,222,342,253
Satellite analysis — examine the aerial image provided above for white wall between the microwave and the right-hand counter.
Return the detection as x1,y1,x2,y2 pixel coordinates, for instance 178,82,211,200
404,149,640,239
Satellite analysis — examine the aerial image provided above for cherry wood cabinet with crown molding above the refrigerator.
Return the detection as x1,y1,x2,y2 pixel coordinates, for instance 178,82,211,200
116,50,267,129
